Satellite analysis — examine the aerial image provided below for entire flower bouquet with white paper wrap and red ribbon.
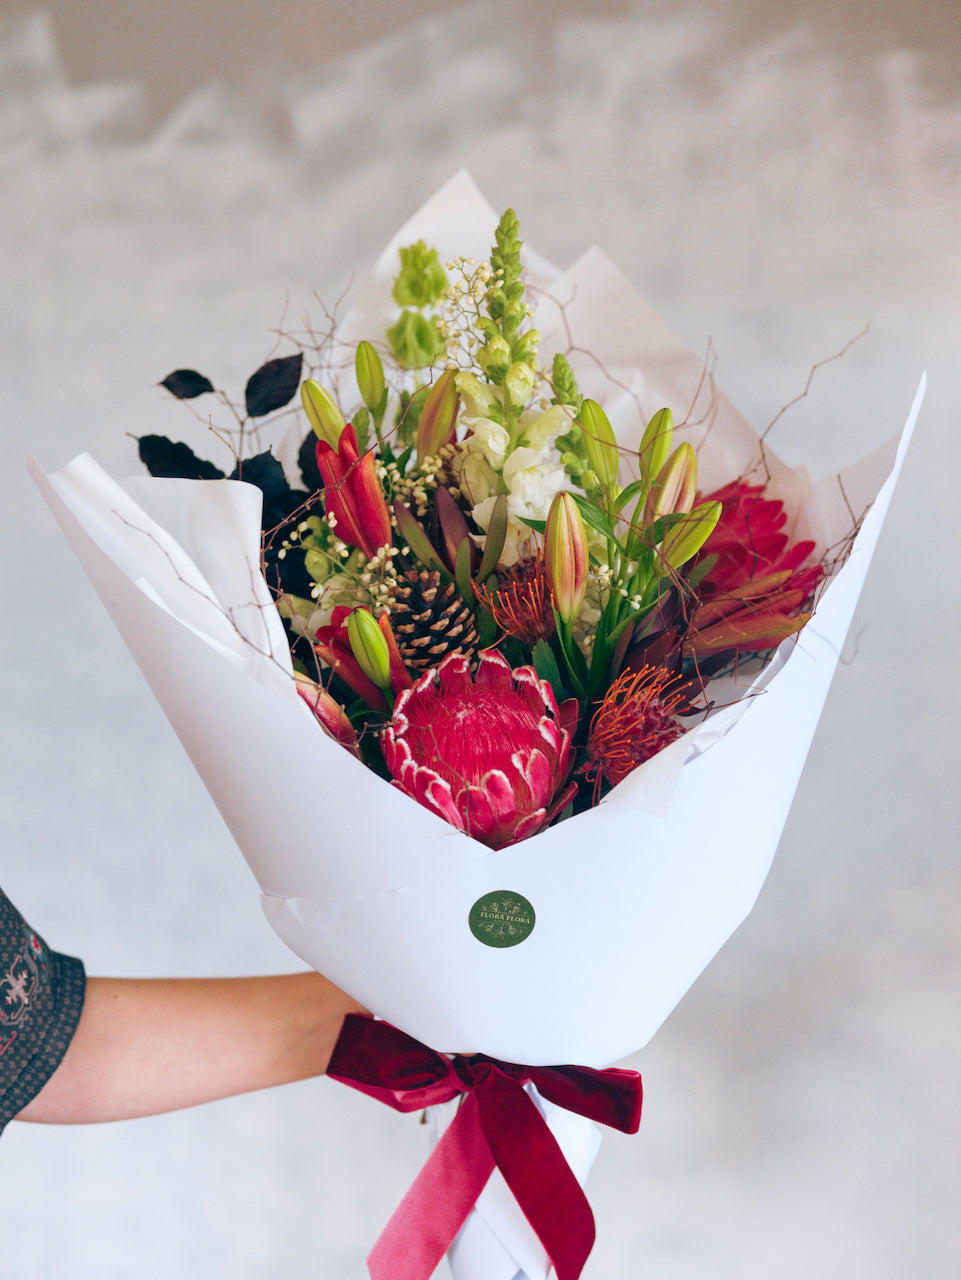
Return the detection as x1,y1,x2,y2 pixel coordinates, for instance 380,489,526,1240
35,174,920,1280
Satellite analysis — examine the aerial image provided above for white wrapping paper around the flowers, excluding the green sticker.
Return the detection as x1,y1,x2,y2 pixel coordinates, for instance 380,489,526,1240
32,175,923,1280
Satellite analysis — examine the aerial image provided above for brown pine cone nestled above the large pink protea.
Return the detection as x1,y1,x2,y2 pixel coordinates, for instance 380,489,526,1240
390,568,477,673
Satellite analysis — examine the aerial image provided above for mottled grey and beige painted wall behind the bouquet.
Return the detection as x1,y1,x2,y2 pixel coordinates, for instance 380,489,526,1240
0,0,961,1280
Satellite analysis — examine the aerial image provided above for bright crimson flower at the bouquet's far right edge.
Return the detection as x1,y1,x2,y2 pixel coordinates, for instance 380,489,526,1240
697,480,823,599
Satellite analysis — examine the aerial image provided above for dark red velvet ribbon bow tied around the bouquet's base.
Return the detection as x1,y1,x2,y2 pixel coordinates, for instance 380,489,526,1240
328,1014,641,1280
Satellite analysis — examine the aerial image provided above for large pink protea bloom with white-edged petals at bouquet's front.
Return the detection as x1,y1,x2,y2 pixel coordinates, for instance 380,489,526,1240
381,652,575,849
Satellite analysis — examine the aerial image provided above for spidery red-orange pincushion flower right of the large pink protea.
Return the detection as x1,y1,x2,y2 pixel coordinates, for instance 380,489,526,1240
585,667,686,804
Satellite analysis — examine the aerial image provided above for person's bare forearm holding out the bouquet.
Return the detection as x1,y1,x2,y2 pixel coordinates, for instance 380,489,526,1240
19,973,361,1124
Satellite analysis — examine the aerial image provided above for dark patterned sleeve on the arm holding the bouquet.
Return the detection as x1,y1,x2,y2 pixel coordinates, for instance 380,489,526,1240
0,891,86,1132
